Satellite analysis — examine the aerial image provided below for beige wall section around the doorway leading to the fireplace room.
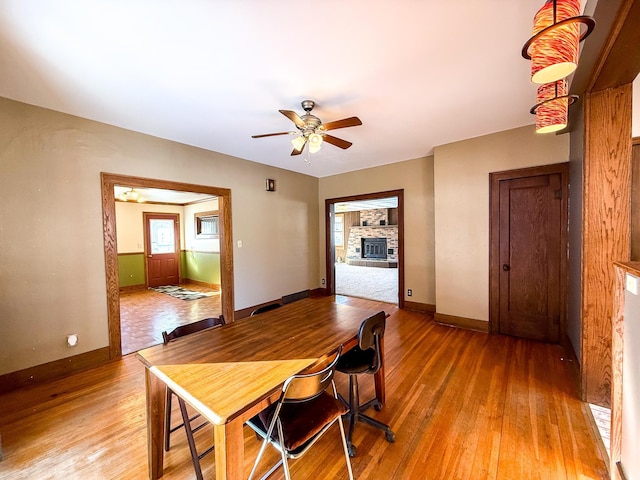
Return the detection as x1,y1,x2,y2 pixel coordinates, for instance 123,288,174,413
319,156,436,305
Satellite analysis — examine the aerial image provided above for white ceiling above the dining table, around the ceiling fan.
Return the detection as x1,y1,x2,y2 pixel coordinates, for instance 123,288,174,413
0,0,589,177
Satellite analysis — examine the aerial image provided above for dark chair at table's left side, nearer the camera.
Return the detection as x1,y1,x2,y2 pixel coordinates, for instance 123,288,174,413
162,315,225,480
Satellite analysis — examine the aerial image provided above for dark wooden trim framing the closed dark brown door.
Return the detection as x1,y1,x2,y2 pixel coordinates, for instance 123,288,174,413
489,162,569,343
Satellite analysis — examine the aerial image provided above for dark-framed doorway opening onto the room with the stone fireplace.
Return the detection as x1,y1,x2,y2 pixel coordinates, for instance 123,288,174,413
325,190,404,308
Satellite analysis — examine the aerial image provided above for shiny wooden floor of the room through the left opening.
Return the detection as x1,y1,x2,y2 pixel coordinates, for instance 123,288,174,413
120,283,222,355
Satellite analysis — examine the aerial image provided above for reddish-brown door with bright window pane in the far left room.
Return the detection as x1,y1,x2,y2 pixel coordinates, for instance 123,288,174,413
144,213,180,287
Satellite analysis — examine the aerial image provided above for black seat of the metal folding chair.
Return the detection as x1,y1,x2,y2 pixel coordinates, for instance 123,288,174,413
252,392,348,452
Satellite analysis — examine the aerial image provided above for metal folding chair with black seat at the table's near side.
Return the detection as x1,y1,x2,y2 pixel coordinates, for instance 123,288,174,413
247,347,353,480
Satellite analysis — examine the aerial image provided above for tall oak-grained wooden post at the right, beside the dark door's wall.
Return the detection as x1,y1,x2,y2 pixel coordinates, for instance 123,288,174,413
581,84,632,407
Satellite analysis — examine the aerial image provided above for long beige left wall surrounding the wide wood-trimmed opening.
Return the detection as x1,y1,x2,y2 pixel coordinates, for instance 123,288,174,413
0,98,320,375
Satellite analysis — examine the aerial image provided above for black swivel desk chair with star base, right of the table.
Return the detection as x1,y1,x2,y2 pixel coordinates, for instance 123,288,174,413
336,311,396,457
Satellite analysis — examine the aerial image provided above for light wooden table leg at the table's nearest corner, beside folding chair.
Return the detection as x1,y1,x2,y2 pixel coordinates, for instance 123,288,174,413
213,419,244,480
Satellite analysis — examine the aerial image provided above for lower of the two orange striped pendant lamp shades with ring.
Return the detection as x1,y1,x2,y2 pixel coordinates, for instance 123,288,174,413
531,79,578,133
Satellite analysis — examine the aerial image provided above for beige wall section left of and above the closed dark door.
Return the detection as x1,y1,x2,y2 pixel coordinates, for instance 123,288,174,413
434,126,569,321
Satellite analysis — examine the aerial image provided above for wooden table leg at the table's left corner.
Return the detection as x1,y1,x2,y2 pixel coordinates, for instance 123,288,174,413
145,368,167,480
